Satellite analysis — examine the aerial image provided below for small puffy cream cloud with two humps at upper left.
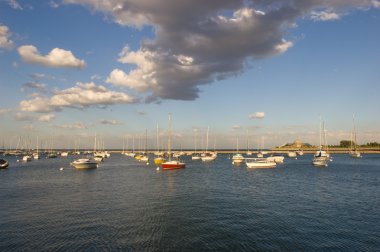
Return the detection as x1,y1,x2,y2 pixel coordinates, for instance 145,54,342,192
18,45,86,69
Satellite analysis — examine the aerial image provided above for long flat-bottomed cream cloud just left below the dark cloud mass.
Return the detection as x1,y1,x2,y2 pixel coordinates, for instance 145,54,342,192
20,82,137,113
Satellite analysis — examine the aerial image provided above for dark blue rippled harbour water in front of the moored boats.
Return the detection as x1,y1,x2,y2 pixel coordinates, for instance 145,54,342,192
0,154,380,251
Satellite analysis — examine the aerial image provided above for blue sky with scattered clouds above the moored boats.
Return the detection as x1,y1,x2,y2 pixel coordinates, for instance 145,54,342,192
0,0,380,149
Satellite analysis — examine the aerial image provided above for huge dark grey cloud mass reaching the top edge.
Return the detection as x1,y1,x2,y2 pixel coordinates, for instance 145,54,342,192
64,0,379,100
